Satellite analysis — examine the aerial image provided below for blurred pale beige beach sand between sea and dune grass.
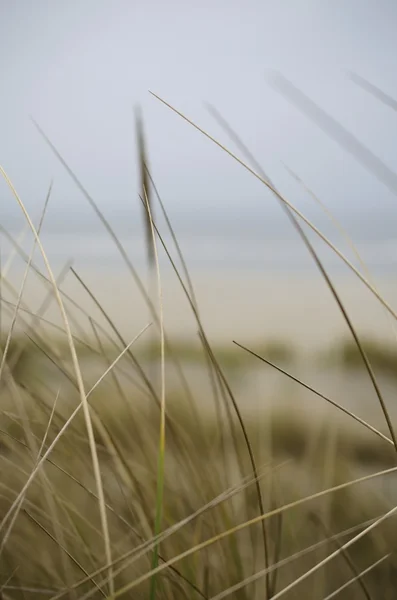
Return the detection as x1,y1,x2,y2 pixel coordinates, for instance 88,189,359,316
3,265,397,351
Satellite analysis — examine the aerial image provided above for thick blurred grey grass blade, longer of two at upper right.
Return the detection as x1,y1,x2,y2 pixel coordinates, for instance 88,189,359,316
271,73,397,195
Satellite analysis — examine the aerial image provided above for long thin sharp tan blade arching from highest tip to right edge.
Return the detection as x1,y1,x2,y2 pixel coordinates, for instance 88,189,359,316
149,92,397,320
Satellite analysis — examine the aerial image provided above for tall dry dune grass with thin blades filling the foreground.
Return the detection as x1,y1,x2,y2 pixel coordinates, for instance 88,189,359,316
0,81,397,600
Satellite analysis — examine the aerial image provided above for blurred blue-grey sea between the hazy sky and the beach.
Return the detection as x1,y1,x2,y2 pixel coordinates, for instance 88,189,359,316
0,191,397,277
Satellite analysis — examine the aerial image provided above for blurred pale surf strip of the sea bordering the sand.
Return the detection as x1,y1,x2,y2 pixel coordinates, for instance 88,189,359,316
1,221,397,277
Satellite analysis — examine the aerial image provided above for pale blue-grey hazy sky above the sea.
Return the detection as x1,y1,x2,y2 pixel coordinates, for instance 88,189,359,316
0,0,397,237
